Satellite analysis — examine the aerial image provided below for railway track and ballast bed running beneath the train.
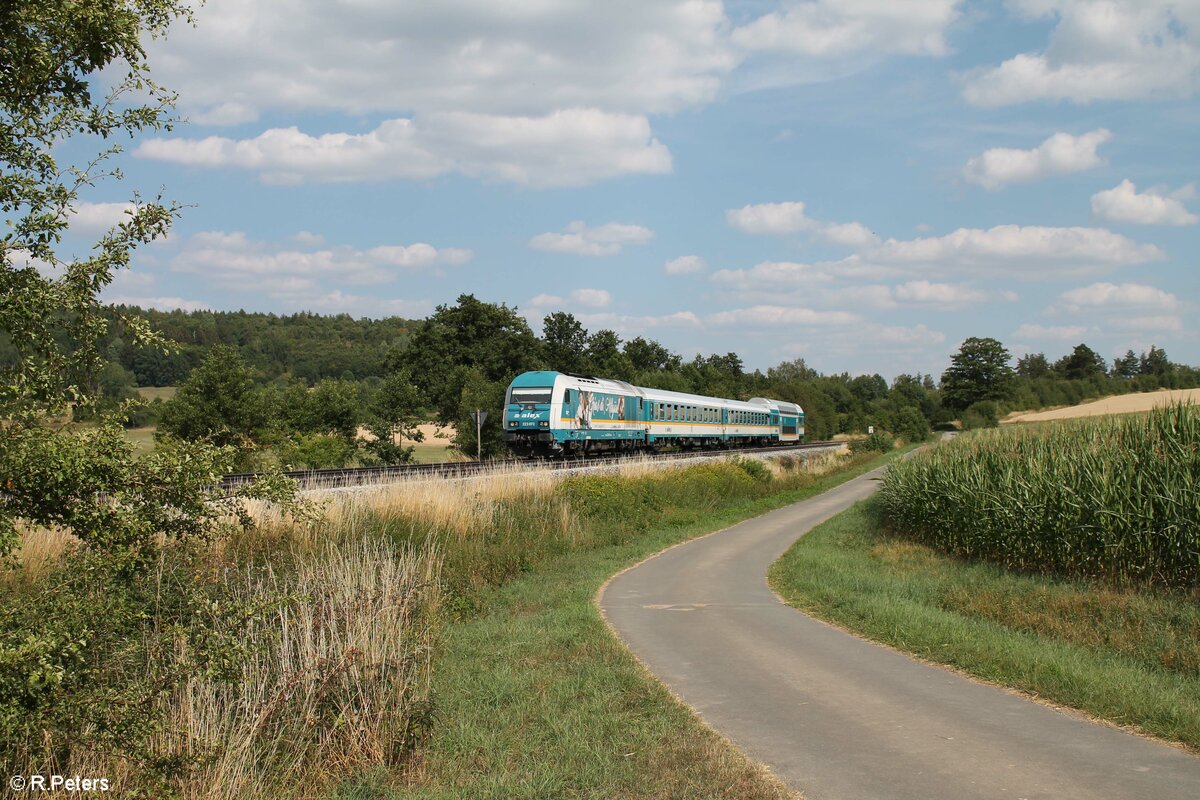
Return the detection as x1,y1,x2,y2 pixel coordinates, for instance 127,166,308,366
221,441,844,489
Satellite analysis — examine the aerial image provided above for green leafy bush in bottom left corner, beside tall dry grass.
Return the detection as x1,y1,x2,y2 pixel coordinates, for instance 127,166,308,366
0,547,258,794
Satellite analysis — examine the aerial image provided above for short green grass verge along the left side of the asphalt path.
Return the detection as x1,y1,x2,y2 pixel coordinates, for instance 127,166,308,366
364,448,907,799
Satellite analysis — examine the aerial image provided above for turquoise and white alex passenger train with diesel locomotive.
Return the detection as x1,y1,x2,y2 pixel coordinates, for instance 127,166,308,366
503,371,804,457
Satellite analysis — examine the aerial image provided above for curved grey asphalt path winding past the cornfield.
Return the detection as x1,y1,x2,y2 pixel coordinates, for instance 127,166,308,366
599,473,1200,800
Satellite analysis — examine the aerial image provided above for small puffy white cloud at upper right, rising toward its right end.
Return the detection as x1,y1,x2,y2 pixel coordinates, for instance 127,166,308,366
962,128,1112,190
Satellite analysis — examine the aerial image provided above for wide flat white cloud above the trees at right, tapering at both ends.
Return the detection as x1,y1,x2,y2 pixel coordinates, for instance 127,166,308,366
859,225,1165,279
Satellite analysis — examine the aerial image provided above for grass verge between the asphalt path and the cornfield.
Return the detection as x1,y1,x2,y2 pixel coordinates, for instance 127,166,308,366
769,499,1200,750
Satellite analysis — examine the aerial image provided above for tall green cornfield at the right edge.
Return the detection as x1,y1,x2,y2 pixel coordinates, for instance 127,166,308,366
880,404,1200,590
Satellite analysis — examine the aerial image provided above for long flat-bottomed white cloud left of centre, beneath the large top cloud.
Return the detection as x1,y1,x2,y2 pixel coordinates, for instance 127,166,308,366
134,108,671,187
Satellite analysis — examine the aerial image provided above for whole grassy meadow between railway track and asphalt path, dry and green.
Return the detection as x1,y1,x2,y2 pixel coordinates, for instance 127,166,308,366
0,453,902,800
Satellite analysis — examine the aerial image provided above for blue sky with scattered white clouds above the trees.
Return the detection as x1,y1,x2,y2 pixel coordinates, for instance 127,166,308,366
72,0,1200,378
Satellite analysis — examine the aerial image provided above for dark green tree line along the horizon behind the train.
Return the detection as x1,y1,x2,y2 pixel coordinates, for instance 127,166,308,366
121,294,1200,469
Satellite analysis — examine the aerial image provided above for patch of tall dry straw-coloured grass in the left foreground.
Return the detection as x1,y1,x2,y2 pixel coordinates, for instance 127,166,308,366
163,540,439,800
